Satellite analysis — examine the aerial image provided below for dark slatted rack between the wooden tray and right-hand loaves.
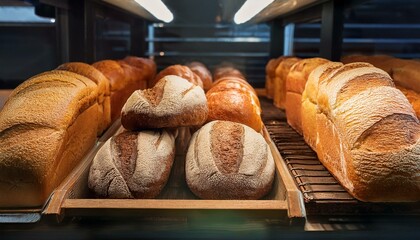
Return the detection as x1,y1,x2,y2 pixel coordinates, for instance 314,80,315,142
261,98,420,217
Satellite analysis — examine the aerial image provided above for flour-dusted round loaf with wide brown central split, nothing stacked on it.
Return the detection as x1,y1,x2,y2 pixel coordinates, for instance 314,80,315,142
185,121,275,199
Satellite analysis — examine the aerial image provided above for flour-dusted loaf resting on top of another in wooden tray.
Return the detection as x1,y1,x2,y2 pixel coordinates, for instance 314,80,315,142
121,75,208,130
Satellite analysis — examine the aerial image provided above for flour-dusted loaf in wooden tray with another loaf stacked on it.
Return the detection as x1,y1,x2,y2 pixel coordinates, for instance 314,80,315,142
88,130,175,198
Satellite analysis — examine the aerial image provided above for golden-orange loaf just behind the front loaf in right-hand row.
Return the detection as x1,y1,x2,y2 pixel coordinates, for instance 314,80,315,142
285,58,328,135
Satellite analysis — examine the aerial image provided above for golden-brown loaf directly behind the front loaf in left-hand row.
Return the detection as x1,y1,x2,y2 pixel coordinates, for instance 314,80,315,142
57,62,111,136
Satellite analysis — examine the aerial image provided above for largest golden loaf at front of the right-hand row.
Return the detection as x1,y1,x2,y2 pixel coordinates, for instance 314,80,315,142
316,63,420,202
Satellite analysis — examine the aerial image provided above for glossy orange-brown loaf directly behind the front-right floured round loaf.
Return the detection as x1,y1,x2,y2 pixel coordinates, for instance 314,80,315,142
206,68,262,132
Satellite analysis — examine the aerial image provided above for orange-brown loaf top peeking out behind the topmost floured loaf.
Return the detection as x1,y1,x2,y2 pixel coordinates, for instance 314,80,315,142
149,64,203,88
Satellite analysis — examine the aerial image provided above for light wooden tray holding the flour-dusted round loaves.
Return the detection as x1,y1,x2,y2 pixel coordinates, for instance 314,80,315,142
43,123,305,224
